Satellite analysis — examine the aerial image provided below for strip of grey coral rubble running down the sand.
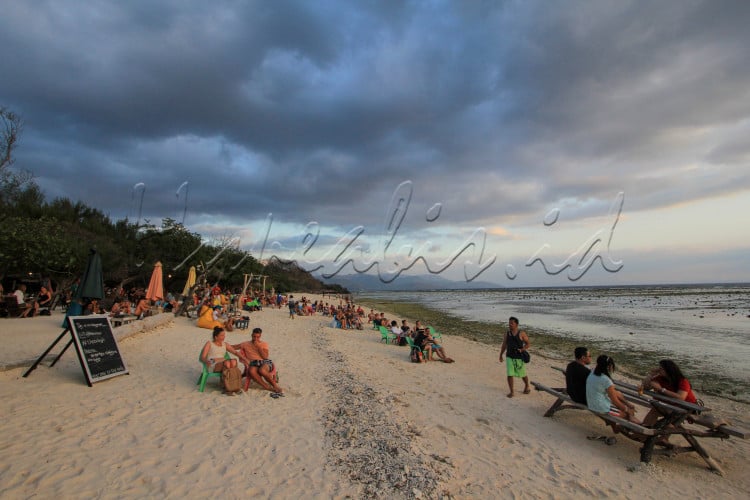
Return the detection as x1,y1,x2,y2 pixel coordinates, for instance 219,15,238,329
313,332,450,498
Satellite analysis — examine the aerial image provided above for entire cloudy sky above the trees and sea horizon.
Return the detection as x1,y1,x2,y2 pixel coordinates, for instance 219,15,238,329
0,0,750,286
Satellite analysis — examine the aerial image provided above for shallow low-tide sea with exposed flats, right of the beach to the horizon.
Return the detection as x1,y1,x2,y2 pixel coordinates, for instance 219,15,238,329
357,284,750,402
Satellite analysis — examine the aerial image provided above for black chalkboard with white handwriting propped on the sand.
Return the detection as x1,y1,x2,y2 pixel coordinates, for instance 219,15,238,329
68,315,128,385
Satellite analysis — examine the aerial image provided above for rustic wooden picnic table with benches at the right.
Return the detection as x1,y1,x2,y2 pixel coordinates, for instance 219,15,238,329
531,370,750,475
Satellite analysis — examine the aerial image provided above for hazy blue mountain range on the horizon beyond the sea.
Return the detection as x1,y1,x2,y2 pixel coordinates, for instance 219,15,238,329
316,274,502,292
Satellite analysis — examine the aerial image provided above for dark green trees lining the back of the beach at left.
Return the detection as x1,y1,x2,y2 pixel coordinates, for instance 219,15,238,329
0,106,348,291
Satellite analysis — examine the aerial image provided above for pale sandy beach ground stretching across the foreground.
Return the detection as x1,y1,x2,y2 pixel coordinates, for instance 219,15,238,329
0,296,750,499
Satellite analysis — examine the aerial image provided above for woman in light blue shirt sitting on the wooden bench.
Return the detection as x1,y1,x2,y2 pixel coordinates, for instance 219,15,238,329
586,354,640,424
